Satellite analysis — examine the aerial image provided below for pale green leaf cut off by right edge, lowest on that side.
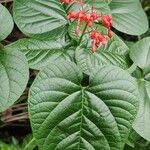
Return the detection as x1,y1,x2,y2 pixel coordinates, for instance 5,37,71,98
133,80,150,141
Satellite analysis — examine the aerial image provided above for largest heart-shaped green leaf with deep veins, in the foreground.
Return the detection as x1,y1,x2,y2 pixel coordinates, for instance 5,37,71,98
29,61,138,150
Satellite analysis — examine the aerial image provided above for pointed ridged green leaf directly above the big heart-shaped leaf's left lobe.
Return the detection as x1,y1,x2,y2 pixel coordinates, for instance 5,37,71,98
7,39,70,70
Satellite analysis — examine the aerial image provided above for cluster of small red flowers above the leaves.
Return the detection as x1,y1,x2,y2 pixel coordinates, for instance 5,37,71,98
61,0,112,53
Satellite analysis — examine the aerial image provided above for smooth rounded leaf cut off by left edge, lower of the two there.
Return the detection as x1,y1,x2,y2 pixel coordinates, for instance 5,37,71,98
0,49,29,112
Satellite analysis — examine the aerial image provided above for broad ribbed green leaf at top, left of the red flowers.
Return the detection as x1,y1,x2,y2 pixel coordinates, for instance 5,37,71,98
13,0,67,39
